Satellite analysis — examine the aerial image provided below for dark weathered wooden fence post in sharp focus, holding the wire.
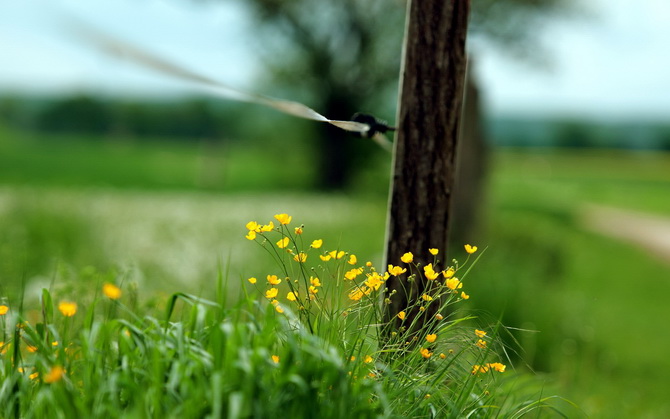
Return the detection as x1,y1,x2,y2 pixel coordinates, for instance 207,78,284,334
384,0,470,332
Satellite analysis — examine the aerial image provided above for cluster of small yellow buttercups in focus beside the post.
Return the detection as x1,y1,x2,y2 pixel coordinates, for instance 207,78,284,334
245,214,504,375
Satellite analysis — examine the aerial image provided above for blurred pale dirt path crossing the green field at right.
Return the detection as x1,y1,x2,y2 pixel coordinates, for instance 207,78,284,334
582,205,670,263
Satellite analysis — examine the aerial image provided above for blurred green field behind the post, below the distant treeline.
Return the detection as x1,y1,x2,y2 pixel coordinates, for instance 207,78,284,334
0,125,670,417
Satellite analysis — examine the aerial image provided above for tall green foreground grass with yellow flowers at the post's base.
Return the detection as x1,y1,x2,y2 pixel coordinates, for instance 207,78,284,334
0,214,576,418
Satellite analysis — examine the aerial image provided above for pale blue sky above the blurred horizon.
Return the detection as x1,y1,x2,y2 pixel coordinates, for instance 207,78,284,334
0,0,670,121
